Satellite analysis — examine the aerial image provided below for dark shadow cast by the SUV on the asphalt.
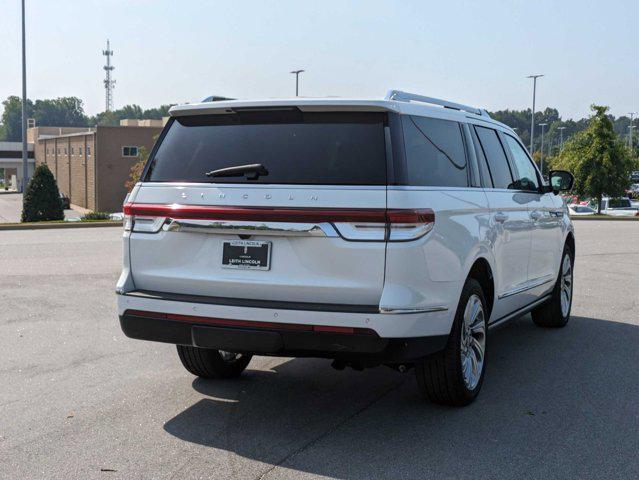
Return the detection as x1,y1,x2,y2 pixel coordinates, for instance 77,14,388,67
164,312,639,479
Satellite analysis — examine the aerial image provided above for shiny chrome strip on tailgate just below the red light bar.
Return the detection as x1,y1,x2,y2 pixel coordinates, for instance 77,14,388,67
162,219,339,237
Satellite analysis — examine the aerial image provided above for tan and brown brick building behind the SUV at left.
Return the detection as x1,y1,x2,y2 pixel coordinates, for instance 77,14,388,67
32,126,162,212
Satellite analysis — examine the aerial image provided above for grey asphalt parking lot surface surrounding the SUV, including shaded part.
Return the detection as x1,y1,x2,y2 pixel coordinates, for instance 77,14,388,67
0,221,639,479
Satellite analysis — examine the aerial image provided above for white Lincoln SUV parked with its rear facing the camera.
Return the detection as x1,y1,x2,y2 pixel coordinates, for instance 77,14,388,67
117,91,575,405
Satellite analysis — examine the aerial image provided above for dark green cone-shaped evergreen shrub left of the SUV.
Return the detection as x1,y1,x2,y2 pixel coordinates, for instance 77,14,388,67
22,163,64,222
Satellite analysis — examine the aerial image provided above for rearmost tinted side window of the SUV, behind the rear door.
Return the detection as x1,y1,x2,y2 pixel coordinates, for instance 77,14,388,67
403,116,468,187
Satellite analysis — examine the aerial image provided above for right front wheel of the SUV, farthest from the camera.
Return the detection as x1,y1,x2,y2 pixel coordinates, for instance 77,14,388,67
531,245,574,328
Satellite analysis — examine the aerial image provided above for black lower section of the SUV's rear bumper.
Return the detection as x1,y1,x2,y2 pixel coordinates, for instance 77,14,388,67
120,310,448,364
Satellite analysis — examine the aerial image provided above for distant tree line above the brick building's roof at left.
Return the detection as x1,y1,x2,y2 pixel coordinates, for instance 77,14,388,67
0,95,171,142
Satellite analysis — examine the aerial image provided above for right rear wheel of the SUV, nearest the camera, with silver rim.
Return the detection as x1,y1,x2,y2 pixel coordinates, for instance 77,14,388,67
415,278,488,407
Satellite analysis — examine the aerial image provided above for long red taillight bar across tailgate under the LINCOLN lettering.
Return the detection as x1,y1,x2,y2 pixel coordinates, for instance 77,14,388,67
124,203,435,223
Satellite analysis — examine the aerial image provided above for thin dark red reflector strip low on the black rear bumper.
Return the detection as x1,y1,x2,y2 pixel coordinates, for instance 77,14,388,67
124,310,375,335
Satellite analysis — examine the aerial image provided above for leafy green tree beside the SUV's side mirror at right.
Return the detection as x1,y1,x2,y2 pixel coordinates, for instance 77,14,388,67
550,105,637,213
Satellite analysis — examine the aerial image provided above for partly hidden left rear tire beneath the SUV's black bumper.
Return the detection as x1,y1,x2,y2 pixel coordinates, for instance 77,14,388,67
177,345,252,378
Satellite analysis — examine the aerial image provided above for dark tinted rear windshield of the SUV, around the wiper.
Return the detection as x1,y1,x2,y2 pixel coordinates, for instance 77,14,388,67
145,109,386,185
